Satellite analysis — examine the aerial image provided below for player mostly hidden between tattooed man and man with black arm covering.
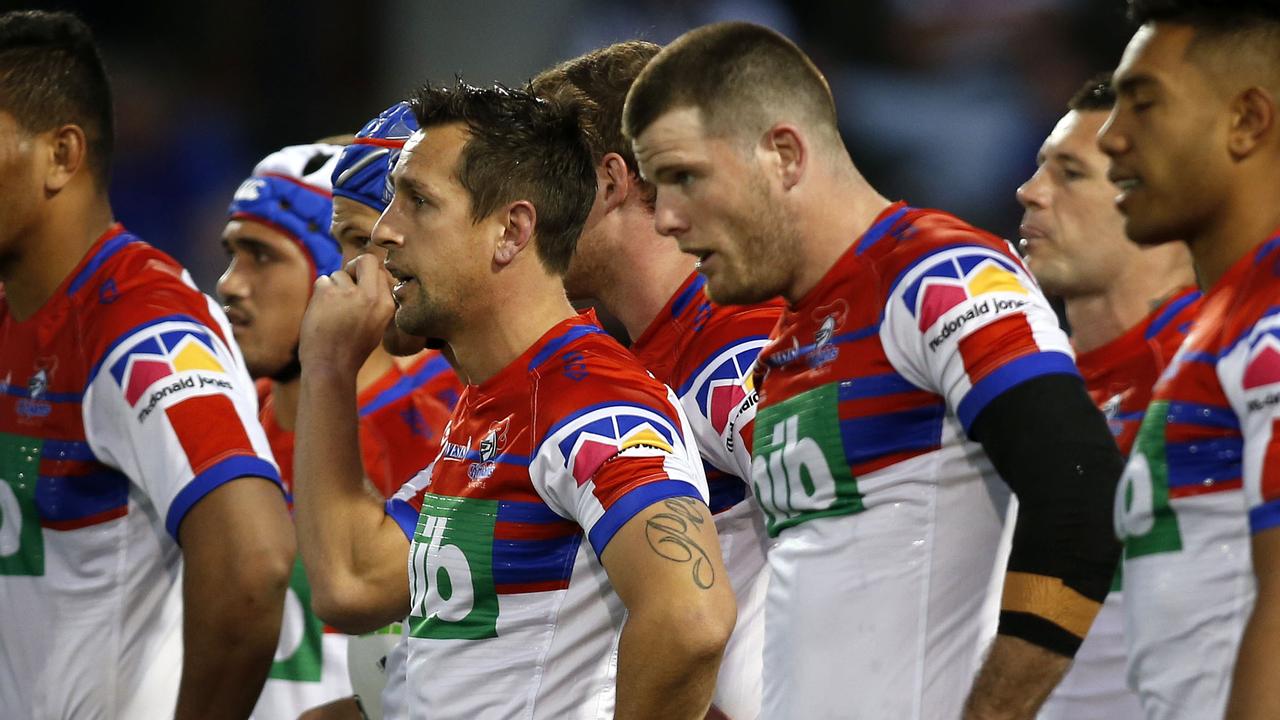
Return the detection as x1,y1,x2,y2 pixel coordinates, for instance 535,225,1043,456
532,41,782,720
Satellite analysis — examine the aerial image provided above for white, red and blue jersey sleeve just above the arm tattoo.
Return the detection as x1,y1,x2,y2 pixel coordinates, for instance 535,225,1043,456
529,391,709,556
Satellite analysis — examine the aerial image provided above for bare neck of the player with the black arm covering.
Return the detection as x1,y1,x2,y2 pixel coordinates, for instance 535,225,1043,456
782,165,891,306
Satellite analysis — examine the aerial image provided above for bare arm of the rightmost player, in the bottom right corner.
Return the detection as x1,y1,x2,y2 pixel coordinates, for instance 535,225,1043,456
1226,528,1280,720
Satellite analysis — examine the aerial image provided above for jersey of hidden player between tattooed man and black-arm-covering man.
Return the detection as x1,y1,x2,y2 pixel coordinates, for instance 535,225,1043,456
631,274,782,719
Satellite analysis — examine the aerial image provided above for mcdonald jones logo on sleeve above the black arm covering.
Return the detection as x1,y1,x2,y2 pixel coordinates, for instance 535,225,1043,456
902,252,1029,351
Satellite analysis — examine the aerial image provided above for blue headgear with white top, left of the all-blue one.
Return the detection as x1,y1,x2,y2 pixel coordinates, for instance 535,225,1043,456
227,143,342,277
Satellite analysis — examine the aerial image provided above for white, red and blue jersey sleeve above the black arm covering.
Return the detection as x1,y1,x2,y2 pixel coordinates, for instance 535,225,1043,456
881,243,1078,432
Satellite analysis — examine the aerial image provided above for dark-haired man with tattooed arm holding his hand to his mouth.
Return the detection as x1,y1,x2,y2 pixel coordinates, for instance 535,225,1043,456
297,83,735,719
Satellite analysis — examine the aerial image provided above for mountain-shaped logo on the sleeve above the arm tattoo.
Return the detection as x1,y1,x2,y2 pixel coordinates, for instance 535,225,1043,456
558,407,676,486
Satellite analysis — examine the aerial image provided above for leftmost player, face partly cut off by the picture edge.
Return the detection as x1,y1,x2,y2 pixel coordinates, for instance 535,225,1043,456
0,12,294,719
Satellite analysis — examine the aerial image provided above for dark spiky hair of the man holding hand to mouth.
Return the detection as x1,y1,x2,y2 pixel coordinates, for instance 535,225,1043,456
410,81,595,275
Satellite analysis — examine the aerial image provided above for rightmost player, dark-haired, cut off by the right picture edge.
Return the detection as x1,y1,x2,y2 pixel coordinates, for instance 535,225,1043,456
1098,0,1280,719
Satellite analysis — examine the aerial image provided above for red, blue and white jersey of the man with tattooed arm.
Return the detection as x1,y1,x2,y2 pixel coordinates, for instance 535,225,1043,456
388,314,707,720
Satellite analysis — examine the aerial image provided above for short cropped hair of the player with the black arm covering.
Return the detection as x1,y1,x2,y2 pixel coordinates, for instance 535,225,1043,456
622,22,840,147
